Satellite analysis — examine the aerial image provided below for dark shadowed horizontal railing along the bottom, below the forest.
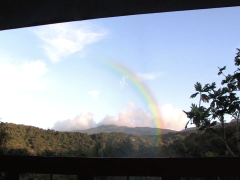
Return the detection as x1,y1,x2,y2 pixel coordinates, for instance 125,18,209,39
0,156,240,179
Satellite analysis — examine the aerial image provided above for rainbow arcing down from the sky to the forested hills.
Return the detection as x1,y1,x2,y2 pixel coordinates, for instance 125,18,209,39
102,62,163,146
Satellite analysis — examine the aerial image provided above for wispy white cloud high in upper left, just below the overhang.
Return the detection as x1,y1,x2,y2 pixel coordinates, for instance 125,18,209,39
34,22,107,63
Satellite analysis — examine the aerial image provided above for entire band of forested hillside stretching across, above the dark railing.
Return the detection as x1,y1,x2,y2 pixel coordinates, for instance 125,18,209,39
0,123,237,157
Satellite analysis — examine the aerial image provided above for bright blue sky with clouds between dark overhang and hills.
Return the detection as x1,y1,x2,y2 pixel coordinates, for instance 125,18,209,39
0,7,240,131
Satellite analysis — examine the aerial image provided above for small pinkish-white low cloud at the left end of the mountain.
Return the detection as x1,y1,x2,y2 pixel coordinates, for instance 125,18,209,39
53,112,96,131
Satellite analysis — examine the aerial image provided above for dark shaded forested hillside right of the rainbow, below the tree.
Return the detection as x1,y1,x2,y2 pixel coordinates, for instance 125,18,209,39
159,122,238,157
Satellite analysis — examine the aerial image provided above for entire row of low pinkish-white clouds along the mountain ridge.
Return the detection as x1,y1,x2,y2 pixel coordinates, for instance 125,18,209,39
53,102,187,131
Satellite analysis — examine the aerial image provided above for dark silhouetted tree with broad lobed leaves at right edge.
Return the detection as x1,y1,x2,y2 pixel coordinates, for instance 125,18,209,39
184,49,240,156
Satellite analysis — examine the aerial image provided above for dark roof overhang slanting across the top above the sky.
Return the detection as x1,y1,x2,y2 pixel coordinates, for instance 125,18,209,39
0,0,240,30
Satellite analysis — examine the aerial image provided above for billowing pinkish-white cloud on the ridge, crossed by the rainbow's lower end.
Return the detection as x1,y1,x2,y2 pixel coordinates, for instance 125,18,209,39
98,102,187,131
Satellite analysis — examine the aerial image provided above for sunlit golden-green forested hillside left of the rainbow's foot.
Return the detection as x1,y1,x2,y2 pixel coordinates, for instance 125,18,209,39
0,123,158,156
